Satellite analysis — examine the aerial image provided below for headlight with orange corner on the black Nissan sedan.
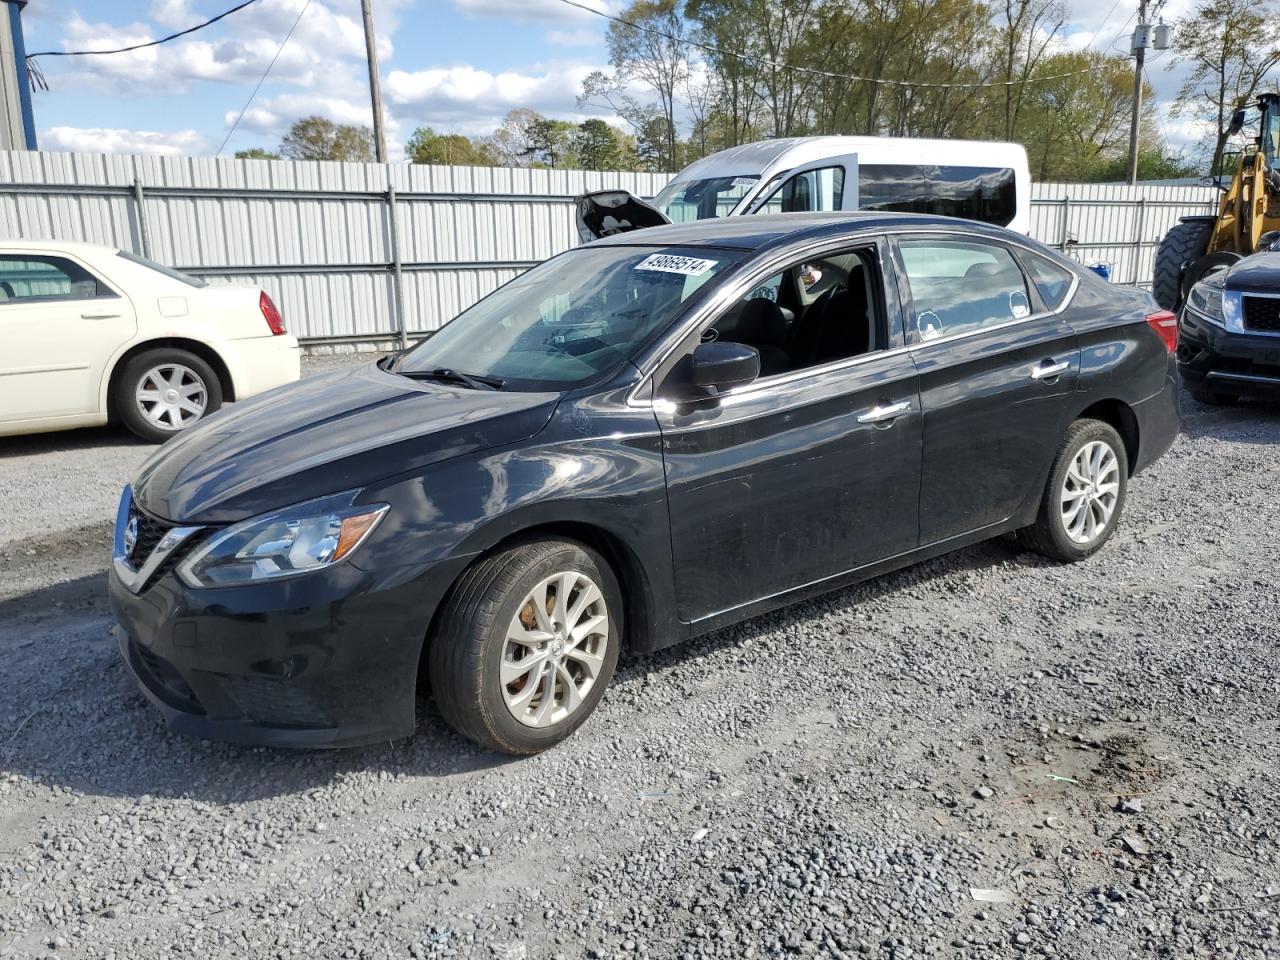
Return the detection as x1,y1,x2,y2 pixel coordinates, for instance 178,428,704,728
178,490,388,588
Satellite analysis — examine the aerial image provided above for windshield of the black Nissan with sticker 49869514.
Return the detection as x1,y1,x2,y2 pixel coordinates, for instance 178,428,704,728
393,246,745,390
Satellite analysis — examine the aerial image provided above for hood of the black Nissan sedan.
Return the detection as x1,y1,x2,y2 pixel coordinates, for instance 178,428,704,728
133,364,559,524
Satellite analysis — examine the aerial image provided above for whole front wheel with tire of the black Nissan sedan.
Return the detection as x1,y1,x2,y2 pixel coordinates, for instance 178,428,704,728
428,539,622,755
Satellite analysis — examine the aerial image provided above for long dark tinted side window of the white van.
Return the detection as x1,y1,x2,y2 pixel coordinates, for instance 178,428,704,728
858,164,1018,227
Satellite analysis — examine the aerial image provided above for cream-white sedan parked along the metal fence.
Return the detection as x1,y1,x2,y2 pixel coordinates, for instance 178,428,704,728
0,241,300,443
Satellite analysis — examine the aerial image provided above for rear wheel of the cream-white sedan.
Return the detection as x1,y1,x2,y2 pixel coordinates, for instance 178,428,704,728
111,348,223,443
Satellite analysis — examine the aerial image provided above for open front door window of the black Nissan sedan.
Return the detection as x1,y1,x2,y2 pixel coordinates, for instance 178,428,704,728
701,247,888,378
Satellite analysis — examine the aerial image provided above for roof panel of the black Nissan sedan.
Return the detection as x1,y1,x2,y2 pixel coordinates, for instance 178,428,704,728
589,211,1020,250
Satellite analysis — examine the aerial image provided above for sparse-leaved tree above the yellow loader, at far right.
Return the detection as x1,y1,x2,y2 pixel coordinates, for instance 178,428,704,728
1174,0,1280,173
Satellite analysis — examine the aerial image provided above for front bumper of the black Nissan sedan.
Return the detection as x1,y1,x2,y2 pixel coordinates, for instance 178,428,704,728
109,547,471,748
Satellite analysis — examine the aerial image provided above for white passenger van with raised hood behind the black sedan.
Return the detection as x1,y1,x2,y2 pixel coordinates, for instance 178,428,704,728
577,137,1030,241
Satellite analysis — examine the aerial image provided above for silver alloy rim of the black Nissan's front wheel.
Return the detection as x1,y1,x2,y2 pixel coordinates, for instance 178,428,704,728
500,571,611,727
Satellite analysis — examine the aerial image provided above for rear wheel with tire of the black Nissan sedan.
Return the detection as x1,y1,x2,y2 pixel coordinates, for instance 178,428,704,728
1018,420,1129,563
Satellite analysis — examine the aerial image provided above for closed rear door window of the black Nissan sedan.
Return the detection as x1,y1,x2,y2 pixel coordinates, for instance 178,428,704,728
899,239,1032,340
